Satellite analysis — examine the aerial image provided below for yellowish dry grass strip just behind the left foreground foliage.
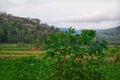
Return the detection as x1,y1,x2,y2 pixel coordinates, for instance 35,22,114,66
0,51,44,59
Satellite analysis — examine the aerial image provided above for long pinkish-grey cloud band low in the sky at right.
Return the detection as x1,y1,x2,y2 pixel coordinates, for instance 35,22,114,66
57,13,120,23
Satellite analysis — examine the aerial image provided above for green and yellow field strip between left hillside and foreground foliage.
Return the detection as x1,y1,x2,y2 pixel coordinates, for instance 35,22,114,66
0,44,44,59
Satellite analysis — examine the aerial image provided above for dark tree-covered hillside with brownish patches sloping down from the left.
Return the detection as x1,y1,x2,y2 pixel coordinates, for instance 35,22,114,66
0,12,60,43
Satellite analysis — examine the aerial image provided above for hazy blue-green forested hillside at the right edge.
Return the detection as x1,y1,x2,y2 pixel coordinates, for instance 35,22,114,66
97,26,120,45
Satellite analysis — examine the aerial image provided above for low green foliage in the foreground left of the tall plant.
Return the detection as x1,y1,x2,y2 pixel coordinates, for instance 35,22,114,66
0,56,54,80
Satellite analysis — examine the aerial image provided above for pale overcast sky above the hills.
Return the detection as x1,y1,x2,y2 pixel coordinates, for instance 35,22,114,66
0,0,120,29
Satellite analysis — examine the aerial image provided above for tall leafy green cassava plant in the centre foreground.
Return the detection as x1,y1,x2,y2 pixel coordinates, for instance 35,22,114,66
43,28,107,80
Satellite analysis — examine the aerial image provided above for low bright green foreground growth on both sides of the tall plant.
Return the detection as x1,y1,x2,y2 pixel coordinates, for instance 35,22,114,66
0,56,120,80
